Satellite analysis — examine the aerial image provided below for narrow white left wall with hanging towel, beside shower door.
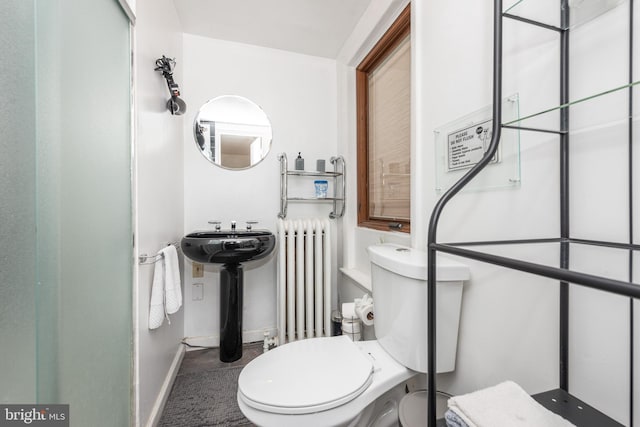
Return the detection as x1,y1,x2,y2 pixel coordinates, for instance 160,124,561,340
134,0,184,425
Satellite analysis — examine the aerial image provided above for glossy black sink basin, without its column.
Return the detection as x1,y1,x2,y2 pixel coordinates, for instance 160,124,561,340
181,230,276,264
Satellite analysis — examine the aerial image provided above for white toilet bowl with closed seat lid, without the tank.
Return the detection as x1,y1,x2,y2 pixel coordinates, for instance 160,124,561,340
238,335,417,427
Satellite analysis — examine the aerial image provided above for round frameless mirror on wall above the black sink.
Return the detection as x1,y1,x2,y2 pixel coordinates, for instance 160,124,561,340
193,95,272,169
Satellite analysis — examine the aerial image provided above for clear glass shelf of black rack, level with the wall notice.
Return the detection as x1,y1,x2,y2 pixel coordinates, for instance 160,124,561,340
502,80,640,132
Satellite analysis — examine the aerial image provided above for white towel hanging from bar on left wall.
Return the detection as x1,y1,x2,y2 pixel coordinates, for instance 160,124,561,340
149,245,182,329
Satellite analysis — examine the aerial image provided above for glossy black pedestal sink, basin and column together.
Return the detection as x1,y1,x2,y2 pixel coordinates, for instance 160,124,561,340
181,230,275,362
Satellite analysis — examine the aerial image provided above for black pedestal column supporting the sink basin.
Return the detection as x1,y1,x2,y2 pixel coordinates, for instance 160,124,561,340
220,264,244,362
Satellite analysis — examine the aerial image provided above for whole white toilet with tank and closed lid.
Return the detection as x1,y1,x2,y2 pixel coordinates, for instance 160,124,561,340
237,244,469,427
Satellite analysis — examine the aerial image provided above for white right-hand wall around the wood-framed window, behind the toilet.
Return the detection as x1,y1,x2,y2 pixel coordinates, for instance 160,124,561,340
338,0,637,423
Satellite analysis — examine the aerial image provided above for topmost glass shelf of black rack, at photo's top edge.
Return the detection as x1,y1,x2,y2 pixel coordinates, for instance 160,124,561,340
504,0,626,29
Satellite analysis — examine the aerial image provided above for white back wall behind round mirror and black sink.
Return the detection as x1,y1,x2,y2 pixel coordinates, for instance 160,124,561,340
183,34,337,345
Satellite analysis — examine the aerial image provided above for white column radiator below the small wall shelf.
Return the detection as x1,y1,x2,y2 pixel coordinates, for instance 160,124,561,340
278,219,331,344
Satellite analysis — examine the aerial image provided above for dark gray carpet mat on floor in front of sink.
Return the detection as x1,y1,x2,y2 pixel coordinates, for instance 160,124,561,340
159,366,253,427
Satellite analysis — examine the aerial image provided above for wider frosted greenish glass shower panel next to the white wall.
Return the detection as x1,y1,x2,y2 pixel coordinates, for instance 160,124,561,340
35,0,133,426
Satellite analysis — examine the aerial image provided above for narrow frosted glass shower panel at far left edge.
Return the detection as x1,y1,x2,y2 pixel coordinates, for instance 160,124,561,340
0,0,36,403
